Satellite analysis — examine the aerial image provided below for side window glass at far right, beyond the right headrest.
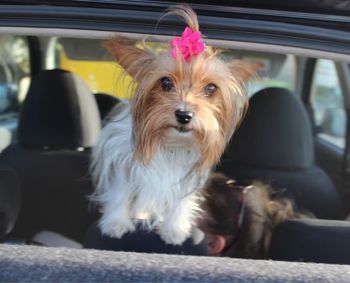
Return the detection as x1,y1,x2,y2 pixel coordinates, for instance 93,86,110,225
303,59,349,202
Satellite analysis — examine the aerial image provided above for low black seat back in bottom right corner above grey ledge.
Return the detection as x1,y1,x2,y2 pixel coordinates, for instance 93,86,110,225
269,219,350,264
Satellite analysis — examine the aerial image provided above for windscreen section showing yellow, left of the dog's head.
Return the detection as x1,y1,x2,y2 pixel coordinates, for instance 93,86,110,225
46,38,131,98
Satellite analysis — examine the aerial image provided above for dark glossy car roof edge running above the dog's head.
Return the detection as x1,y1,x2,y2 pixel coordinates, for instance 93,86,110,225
0,0,350,61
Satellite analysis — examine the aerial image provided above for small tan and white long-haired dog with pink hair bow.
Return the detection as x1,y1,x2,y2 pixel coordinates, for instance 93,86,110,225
91,6,259,245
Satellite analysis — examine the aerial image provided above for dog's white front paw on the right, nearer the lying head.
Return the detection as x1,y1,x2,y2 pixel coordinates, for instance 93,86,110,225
158,223,191,245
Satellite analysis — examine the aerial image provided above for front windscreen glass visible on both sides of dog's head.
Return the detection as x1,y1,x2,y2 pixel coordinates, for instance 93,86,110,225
47,38,296,98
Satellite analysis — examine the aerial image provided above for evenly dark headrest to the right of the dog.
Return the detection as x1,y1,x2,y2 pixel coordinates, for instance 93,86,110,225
226,88,314,169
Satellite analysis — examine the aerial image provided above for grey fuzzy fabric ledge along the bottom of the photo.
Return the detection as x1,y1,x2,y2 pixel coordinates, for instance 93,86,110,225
0,245,350,283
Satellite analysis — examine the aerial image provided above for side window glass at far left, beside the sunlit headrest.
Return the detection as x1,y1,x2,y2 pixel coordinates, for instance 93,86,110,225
0,35,30,151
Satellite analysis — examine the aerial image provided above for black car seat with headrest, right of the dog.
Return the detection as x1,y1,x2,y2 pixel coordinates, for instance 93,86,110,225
218,88,343,219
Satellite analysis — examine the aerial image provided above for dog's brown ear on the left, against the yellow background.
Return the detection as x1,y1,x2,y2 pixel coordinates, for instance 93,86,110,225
103,37,154,77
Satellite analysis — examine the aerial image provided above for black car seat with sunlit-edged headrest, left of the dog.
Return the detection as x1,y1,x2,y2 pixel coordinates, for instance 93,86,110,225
0,69,101,244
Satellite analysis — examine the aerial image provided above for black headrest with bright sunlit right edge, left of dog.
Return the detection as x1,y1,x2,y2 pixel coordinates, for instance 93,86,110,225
18,69,101,148
